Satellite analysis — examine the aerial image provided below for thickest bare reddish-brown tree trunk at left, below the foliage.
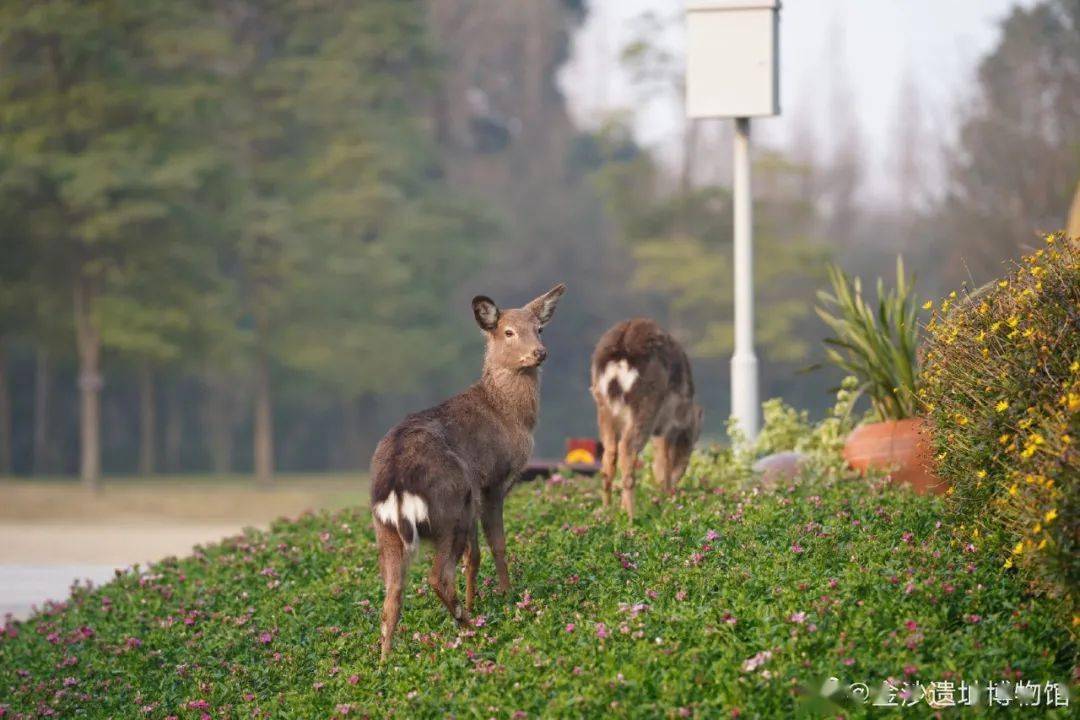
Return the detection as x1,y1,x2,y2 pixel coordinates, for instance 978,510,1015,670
75,276,102,490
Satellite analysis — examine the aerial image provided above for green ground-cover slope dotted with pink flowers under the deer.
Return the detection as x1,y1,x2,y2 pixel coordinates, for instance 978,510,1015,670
0,461,1076,719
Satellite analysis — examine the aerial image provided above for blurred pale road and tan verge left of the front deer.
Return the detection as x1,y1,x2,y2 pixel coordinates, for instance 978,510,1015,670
0,474,367,621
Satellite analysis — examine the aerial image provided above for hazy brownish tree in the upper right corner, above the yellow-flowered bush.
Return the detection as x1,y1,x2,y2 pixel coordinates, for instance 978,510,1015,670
940,0,1080,282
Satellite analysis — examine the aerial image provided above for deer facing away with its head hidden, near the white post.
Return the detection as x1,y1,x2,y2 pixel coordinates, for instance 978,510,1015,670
592,318,703,521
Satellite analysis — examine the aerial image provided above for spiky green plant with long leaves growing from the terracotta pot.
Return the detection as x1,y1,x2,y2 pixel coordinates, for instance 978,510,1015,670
815,256,919,420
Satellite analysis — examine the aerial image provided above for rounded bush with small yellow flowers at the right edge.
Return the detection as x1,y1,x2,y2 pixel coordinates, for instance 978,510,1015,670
921,233,1080,624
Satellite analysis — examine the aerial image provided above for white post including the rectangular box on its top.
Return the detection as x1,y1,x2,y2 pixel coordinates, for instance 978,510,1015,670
686,0,780,439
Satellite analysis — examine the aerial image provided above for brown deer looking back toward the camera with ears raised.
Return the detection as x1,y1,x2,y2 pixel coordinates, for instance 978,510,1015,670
372,285,566,661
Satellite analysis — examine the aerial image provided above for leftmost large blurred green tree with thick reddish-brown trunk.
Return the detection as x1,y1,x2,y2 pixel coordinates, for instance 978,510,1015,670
0,0,232,487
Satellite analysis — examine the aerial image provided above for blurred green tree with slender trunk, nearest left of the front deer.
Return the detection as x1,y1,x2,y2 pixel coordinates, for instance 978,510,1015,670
198,0,490,484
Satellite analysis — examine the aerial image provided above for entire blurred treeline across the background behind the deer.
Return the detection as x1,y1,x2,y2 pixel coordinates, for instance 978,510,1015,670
0,0,1080,485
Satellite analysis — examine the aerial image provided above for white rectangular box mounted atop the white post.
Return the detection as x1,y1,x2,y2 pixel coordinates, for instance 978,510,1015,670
686,0,780,118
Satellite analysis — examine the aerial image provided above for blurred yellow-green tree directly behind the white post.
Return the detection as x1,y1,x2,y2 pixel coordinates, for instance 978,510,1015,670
594,125,824,362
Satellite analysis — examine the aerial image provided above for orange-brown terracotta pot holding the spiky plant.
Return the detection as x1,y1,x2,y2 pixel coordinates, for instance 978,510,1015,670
843,418,947,494
